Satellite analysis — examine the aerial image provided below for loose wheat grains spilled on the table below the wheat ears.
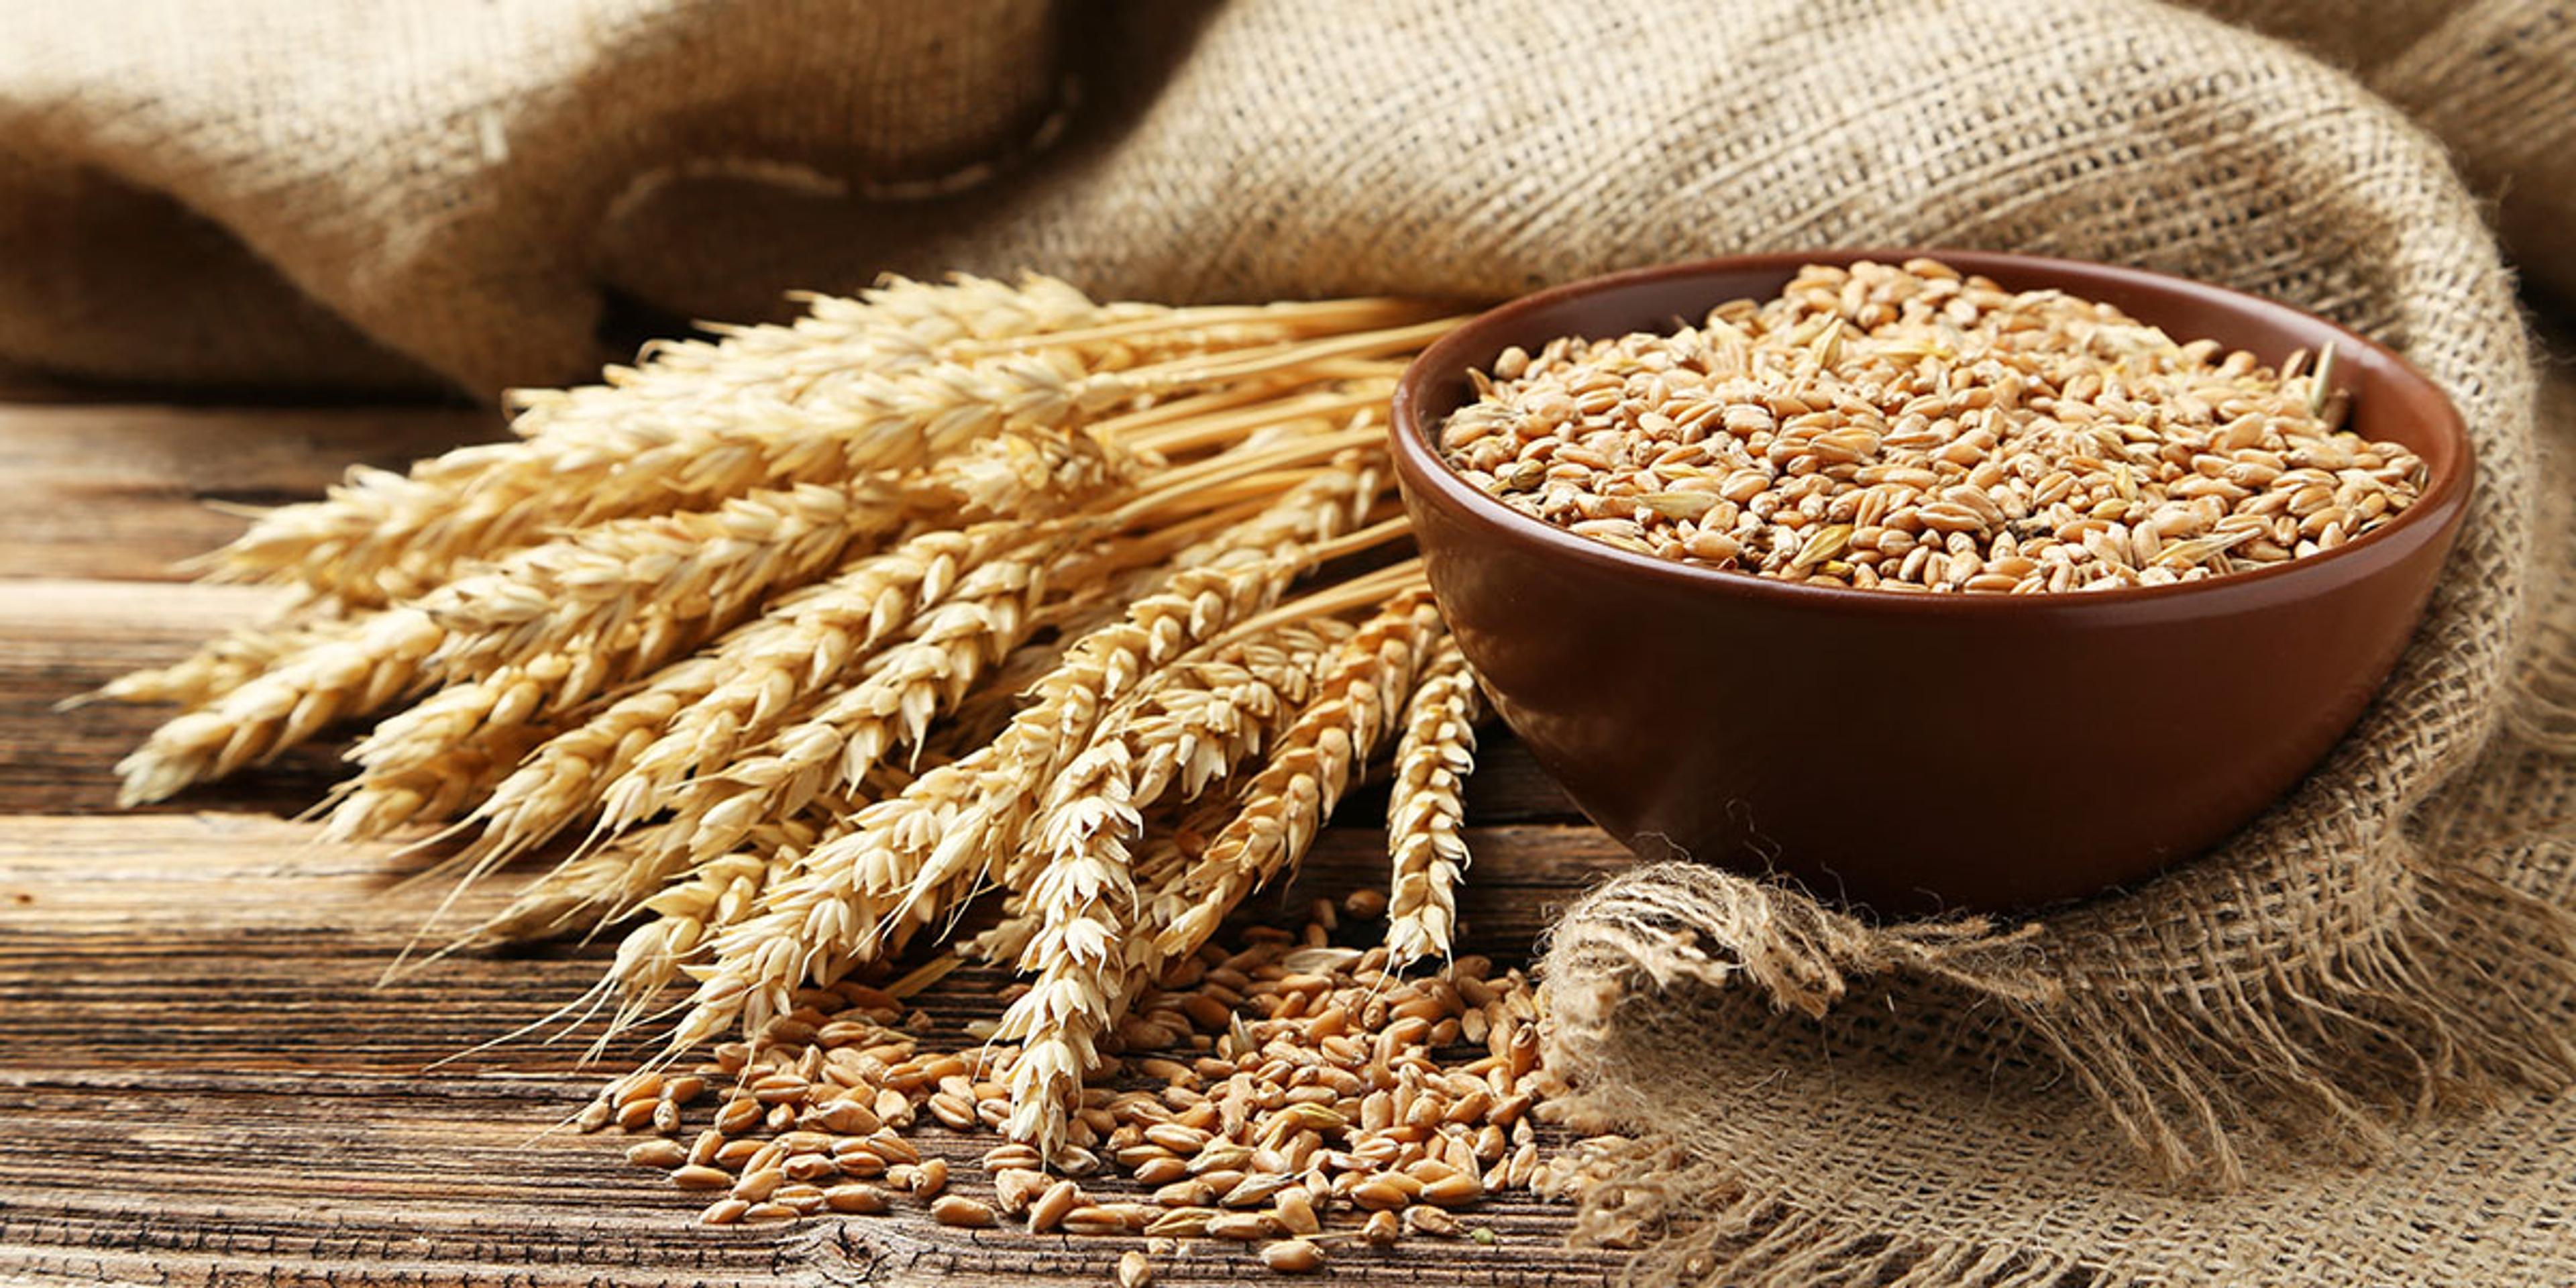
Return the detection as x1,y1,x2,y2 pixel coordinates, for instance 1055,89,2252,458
580,892,1569,1273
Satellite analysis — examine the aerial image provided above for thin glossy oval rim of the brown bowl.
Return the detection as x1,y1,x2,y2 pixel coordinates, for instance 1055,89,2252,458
1389,248,2475,613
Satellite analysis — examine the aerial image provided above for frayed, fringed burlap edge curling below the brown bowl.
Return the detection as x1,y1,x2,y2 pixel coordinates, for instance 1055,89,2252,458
1540,840,2576,1187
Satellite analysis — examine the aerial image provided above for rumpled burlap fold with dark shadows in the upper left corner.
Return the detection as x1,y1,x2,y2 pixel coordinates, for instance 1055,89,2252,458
0,0,1067,396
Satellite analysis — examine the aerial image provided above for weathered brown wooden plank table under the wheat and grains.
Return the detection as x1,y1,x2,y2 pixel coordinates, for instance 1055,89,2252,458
0,388,1620,1288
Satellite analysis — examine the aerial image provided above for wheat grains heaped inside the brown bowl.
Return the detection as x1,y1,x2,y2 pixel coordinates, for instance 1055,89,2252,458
1438,260,2424,595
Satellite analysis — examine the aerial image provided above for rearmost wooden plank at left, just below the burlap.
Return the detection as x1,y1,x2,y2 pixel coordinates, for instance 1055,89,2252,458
0,402,505,582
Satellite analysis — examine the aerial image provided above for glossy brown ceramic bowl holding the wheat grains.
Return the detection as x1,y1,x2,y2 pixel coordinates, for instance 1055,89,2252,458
1393,250,2471,912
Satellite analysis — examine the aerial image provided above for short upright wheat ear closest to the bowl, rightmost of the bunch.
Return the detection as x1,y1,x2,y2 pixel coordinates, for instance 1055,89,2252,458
1386,634,1476,969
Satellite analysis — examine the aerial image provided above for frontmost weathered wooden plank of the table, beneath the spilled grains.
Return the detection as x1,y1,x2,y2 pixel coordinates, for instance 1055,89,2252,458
0,814,1620,1285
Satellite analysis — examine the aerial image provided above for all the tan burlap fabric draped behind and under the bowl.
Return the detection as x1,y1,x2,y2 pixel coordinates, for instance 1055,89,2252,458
0,0,2576,1285
